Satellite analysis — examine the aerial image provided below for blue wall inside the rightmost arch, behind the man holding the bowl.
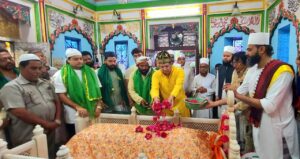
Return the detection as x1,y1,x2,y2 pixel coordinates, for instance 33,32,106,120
271,19,297,70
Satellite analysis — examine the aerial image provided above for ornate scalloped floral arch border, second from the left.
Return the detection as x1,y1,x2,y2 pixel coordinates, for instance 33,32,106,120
102,24,140,50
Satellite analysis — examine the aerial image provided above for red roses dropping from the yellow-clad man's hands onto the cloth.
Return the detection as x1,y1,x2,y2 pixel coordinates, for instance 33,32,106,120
135,100,176,140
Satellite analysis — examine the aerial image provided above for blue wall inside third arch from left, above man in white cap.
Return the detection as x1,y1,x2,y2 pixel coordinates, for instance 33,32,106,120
210,29,249,73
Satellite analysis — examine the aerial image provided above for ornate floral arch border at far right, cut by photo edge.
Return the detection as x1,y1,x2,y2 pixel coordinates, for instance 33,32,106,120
270,2,299,49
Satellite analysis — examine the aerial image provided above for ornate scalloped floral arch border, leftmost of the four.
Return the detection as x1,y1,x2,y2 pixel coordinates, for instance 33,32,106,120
49,19,97,55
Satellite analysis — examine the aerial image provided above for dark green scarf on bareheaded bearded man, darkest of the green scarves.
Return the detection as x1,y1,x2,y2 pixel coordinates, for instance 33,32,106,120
98,64,130,113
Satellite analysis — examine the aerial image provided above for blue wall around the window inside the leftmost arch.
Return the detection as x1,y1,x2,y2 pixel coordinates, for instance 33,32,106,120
52,30,93,66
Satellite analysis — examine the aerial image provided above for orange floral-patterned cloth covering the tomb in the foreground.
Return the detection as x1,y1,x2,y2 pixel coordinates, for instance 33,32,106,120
67,124,213,159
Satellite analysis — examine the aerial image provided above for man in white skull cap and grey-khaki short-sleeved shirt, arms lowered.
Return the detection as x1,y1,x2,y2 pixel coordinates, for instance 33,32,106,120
0,54,61,158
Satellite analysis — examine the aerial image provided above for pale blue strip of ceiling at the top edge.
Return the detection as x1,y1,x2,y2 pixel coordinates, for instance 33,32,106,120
84,0,157,6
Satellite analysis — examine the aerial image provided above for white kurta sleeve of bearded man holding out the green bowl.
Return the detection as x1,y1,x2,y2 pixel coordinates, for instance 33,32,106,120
260,72,293,114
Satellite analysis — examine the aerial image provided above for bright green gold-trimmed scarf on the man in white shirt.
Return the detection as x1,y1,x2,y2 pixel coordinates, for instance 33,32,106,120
61,64,101,117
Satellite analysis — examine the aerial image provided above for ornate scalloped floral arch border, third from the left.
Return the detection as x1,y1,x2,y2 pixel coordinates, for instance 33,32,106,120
208,17,255,54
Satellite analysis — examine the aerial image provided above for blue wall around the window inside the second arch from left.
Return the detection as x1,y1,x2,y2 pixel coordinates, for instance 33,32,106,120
105,34,137,67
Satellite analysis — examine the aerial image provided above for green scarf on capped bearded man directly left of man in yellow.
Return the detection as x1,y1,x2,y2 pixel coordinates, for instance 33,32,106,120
133,68,154,115
